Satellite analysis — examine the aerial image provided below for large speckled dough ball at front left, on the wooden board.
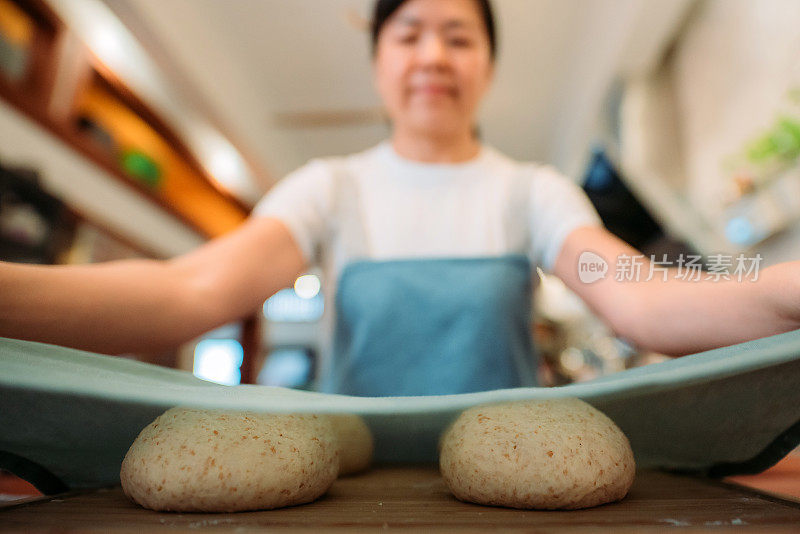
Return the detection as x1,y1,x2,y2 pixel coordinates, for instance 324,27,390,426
120,408,339,512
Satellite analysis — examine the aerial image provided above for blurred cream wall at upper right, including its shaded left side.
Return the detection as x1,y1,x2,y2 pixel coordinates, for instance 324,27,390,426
622,0,800,264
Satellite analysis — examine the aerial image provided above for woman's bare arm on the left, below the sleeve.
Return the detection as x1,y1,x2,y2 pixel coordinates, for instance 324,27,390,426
0,218,305,354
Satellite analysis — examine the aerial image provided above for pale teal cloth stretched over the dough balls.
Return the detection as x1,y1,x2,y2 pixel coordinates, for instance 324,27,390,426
0,330,800,494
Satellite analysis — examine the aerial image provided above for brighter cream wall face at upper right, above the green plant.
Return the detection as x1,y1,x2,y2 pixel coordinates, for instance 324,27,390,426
672,0,800,222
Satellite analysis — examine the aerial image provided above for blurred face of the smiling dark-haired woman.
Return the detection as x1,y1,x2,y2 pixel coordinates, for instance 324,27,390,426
374,0,493,140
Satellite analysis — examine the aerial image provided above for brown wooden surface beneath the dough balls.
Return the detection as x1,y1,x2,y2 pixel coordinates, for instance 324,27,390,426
0,466,800,533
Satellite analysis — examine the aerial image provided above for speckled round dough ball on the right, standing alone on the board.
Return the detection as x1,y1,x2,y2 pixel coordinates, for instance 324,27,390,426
439,399,635,510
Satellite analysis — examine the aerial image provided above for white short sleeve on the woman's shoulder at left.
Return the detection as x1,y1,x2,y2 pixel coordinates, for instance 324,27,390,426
251,160,332,264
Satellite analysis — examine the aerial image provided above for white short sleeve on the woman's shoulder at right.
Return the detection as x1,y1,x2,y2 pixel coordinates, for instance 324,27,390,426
530,166,603,272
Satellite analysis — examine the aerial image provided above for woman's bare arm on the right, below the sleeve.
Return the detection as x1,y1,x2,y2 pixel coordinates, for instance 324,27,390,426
553,227,800,355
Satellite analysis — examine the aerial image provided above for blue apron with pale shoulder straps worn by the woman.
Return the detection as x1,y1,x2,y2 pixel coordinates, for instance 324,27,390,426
320,161,536,397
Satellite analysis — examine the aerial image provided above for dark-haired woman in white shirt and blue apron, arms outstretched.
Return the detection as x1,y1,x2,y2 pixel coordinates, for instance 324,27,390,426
0,0,800,395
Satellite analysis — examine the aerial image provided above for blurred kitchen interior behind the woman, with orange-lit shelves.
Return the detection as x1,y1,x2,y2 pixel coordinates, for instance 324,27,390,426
0,0,800,388
